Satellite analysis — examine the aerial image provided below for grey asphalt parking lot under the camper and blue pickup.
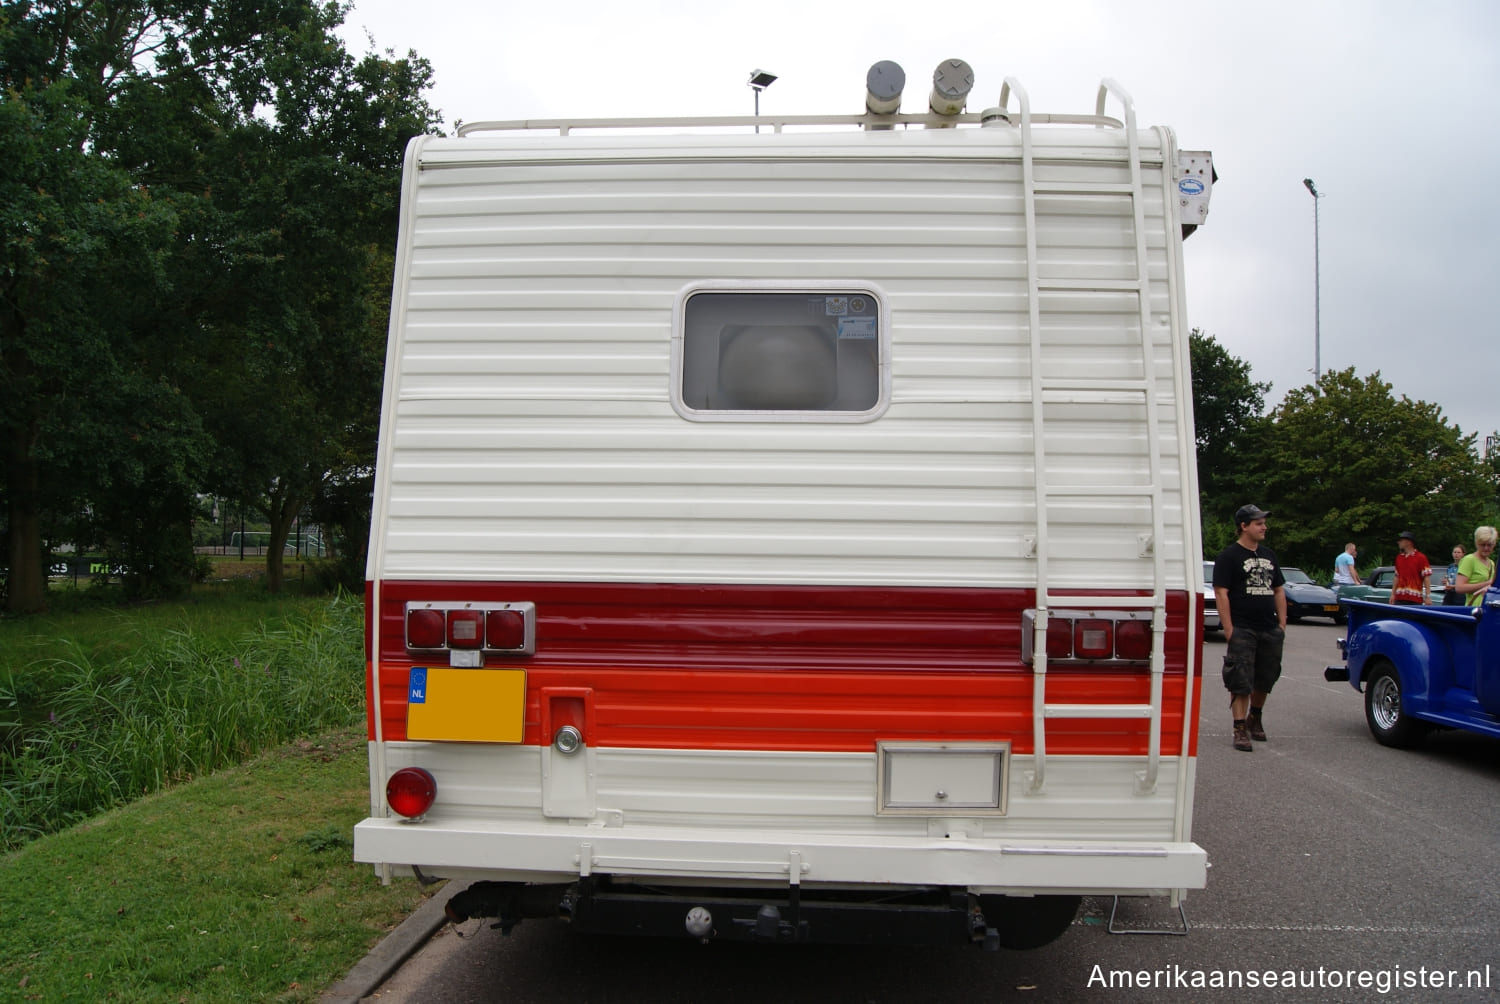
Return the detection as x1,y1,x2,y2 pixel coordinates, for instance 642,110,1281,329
340,621,1500,1004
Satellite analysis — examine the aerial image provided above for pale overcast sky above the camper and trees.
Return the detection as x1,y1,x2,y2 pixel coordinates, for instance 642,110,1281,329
345,0,1500,447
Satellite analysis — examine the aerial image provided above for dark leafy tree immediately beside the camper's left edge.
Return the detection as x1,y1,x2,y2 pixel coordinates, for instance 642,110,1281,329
181,33,437,591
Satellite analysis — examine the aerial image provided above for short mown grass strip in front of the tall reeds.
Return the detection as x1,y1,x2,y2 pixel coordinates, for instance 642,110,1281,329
0,729,435,1002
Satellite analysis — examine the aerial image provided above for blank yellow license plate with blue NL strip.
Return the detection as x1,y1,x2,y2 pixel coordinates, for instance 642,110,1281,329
407,666,527,743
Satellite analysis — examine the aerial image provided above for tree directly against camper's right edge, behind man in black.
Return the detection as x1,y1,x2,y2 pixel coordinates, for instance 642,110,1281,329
1188,329,1271,554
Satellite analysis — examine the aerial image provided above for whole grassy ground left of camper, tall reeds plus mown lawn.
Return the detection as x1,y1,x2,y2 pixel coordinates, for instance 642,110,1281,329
0,581,435,1002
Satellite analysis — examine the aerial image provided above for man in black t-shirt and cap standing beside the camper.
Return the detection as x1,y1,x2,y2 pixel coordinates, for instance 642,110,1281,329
1214,506,1287,753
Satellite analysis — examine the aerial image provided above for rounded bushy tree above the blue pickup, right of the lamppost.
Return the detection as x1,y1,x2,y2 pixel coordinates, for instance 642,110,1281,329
1251,368,1496,567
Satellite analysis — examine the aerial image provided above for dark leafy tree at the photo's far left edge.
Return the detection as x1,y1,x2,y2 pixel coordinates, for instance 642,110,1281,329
0,51,186,611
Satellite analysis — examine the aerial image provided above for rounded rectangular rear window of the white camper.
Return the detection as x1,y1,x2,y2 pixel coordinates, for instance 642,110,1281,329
678,290,884,419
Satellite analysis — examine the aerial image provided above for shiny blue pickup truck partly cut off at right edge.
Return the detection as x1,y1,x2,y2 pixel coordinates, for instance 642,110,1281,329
1323,588,1500,746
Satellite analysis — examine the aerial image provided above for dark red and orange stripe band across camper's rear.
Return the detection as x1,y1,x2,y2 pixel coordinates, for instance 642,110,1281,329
366,582,1202,755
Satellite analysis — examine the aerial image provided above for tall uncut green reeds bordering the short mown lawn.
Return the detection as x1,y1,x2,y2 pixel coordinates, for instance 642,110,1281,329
0,594,365,848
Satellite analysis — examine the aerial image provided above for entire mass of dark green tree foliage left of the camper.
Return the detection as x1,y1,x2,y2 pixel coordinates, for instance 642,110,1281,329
0,0,437,609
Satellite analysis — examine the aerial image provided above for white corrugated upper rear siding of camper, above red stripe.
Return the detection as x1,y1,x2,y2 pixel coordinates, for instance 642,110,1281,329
371,129,1197,588
